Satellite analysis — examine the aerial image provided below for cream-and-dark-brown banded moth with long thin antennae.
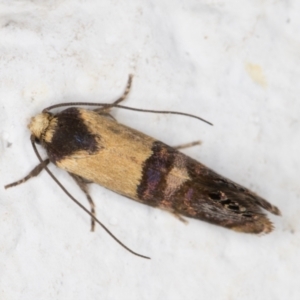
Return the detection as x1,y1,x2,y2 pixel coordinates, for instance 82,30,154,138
5,76,280,258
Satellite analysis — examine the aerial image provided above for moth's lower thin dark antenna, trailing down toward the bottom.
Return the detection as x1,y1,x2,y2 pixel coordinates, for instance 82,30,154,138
30,135,150,259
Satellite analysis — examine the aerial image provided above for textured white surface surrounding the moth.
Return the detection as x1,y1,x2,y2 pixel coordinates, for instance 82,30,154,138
0,0,300,300
